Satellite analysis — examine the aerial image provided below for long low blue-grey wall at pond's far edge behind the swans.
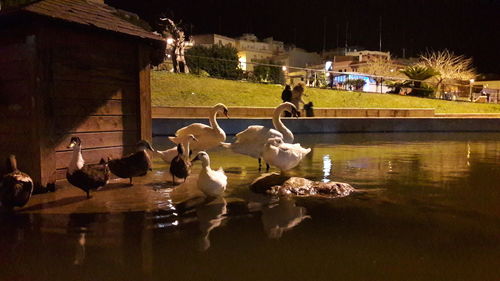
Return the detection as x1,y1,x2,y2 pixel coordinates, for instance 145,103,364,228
153,118,500,135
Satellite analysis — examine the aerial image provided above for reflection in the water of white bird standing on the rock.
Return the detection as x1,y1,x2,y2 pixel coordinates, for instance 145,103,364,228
262,197,311,239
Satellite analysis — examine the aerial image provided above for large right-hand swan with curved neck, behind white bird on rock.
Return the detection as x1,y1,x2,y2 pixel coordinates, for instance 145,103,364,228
222,102,297,169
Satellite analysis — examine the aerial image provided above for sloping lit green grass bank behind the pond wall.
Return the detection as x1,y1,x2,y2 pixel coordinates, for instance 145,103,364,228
151,71,500,113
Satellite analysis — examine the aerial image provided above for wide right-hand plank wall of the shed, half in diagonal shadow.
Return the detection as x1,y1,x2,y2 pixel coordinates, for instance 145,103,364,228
43,27,141,179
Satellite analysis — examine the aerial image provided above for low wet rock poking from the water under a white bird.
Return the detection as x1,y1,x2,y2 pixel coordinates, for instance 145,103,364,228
251,174,355,197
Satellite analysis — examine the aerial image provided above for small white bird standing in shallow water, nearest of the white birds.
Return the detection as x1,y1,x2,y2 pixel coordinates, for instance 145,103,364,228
193,151,227,197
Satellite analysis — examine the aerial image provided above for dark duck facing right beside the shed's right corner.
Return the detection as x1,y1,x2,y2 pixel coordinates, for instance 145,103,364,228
108,140,153,185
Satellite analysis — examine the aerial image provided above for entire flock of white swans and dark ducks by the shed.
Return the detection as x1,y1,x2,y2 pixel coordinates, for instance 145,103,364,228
0,102,311,208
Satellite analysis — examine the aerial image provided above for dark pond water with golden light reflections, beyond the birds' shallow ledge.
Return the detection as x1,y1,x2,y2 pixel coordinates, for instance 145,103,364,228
0,134,500,280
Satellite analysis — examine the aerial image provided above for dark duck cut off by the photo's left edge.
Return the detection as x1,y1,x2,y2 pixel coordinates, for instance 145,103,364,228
0,155,33,210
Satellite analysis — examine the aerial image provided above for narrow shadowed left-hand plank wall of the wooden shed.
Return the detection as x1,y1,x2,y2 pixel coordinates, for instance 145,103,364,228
0,37,40,181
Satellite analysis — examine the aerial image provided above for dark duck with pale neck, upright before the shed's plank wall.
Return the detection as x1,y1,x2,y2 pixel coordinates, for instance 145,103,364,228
66,137,109,198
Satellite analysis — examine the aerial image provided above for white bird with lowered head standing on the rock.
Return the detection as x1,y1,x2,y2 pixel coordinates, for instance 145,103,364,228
262,138,311,171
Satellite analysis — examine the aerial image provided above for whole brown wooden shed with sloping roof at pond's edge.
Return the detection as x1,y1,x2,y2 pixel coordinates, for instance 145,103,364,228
0,0,165,187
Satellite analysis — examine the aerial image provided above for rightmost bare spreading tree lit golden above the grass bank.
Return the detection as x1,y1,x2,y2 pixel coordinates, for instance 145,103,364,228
419,49,477,95
